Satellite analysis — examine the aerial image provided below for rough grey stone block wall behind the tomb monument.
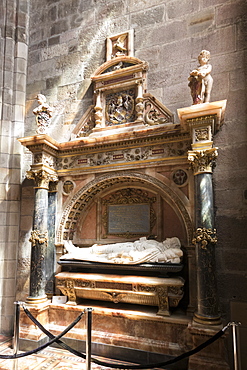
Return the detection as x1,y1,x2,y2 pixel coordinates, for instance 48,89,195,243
20,0,247,324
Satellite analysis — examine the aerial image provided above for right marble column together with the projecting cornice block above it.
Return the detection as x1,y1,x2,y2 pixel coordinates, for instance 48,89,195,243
178,100,226,325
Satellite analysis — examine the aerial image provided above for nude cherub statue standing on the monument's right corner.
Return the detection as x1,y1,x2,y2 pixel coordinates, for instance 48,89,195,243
188,50,213,104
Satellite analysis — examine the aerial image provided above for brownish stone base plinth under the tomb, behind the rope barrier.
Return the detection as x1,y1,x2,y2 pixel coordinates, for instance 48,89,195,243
20,301,229,370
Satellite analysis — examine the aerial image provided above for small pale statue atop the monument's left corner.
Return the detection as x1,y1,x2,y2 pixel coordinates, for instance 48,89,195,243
33,94,53,134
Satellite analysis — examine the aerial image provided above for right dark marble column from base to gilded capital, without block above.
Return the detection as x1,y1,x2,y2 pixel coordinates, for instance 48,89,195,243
189,148,221,325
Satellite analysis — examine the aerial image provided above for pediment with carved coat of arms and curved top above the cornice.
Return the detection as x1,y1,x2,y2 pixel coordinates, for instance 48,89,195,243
71,56,174,140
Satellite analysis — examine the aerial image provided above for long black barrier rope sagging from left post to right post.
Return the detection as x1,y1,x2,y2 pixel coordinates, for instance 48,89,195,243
20,307,229,370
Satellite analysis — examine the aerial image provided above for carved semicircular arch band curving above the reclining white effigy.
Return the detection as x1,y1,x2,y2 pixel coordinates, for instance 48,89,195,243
56,171,193,244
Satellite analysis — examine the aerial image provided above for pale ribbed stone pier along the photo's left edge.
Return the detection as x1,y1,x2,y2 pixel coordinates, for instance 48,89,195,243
0,0,28,333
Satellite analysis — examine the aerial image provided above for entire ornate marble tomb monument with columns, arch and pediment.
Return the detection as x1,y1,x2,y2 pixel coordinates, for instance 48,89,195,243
19,31,228,370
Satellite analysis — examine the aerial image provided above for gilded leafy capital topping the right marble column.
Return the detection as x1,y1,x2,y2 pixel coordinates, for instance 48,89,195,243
188,148,218,175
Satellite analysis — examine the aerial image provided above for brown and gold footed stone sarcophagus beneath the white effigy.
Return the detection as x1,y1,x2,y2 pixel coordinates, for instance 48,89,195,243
56,271,184,316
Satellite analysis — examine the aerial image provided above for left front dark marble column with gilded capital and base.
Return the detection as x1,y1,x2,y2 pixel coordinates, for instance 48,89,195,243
27,169,57,304
